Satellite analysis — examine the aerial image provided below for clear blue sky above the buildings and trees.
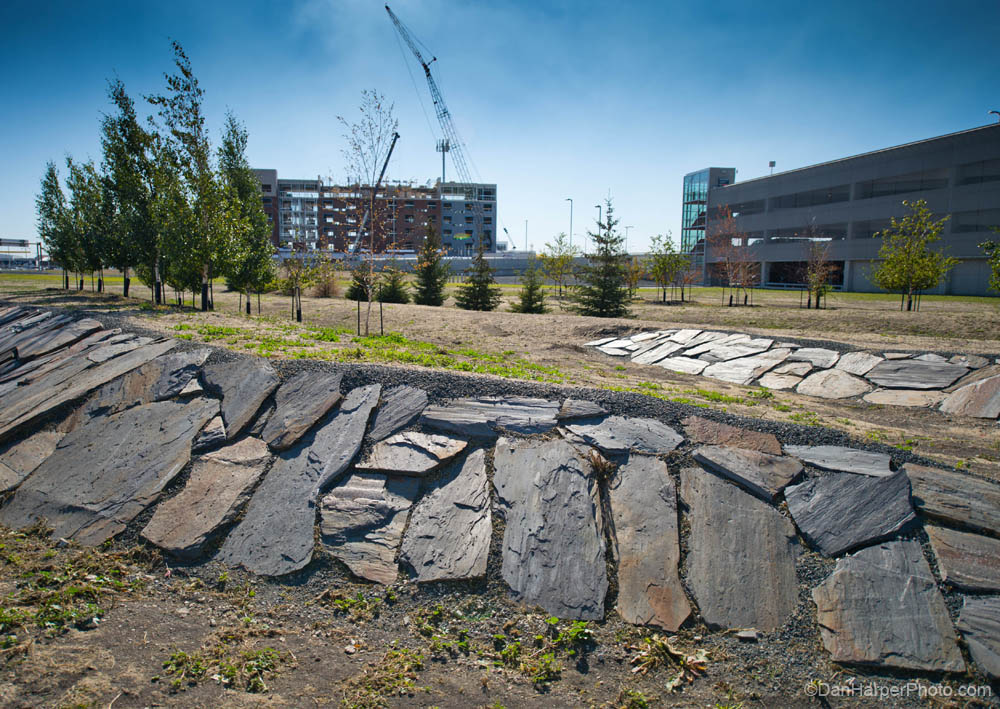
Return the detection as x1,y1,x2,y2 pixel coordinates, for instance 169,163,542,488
0,0,1000,250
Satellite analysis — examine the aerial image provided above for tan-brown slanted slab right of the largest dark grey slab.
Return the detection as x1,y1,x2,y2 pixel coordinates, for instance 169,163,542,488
142,438,270,558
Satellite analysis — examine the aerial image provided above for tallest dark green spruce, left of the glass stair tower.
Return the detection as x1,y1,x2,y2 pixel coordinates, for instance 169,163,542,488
574,199,629,318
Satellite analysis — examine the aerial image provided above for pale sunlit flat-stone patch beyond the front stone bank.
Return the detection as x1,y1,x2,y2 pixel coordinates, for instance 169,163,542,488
584,329,1000,419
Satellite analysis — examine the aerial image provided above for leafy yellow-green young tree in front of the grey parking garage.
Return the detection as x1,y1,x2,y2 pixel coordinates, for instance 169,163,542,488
872,199,958,311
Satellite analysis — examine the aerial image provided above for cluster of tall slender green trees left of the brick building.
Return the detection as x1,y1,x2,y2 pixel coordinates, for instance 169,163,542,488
35,42,275,310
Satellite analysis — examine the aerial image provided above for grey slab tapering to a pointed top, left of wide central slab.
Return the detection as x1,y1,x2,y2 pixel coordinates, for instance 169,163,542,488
399,448,493,583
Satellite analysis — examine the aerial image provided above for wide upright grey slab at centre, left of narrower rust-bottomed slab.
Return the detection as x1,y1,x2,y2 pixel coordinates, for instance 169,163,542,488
493,438,608,620
